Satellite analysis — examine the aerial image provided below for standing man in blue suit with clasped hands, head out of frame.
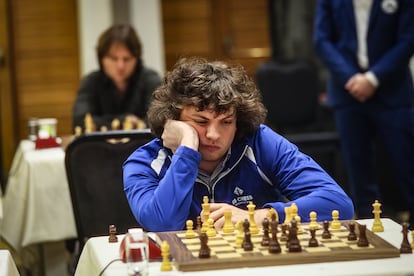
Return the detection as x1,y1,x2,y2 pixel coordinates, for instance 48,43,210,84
314,0,414,227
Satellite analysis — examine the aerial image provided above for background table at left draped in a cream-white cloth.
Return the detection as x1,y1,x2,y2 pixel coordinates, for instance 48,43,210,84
0,140,76,270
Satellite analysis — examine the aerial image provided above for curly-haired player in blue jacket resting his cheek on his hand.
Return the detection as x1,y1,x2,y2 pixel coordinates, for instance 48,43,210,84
123,58,354,231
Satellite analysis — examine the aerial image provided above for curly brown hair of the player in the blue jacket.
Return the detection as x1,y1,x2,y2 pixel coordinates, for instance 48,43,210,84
147,57,267,139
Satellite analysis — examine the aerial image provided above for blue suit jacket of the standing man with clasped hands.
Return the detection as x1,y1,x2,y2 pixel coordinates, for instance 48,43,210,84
314,0,414,106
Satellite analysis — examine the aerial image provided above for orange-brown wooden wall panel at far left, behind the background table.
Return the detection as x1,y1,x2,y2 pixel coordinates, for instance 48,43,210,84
11,0,79,139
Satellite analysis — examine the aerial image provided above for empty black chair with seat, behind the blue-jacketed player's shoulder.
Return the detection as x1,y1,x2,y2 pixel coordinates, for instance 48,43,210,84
255,59,348,190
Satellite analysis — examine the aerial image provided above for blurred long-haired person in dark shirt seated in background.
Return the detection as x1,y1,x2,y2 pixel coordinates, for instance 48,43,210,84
73,24,161,130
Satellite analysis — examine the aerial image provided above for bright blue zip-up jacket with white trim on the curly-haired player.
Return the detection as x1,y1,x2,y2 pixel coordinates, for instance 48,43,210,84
123,125,354,231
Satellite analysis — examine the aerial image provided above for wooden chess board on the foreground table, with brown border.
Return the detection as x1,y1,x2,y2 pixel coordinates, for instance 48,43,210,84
157,221,400,271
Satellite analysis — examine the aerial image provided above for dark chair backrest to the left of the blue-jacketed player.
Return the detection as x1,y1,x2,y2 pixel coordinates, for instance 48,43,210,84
65,130,154,248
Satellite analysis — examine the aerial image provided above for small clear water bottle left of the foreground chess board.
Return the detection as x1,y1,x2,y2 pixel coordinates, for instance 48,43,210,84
125,228,149,276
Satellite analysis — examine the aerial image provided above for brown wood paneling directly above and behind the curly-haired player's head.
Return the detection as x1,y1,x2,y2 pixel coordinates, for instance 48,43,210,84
162,0,271,75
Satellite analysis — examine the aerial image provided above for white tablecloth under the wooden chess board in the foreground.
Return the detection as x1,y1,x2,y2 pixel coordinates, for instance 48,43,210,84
75,219,414,276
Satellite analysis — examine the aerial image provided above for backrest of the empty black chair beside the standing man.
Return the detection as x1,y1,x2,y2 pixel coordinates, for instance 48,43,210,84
256,59,318,132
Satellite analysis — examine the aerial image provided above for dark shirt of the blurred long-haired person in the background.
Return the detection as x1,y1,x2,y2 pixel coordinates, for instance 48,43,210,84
73,65,161,129
